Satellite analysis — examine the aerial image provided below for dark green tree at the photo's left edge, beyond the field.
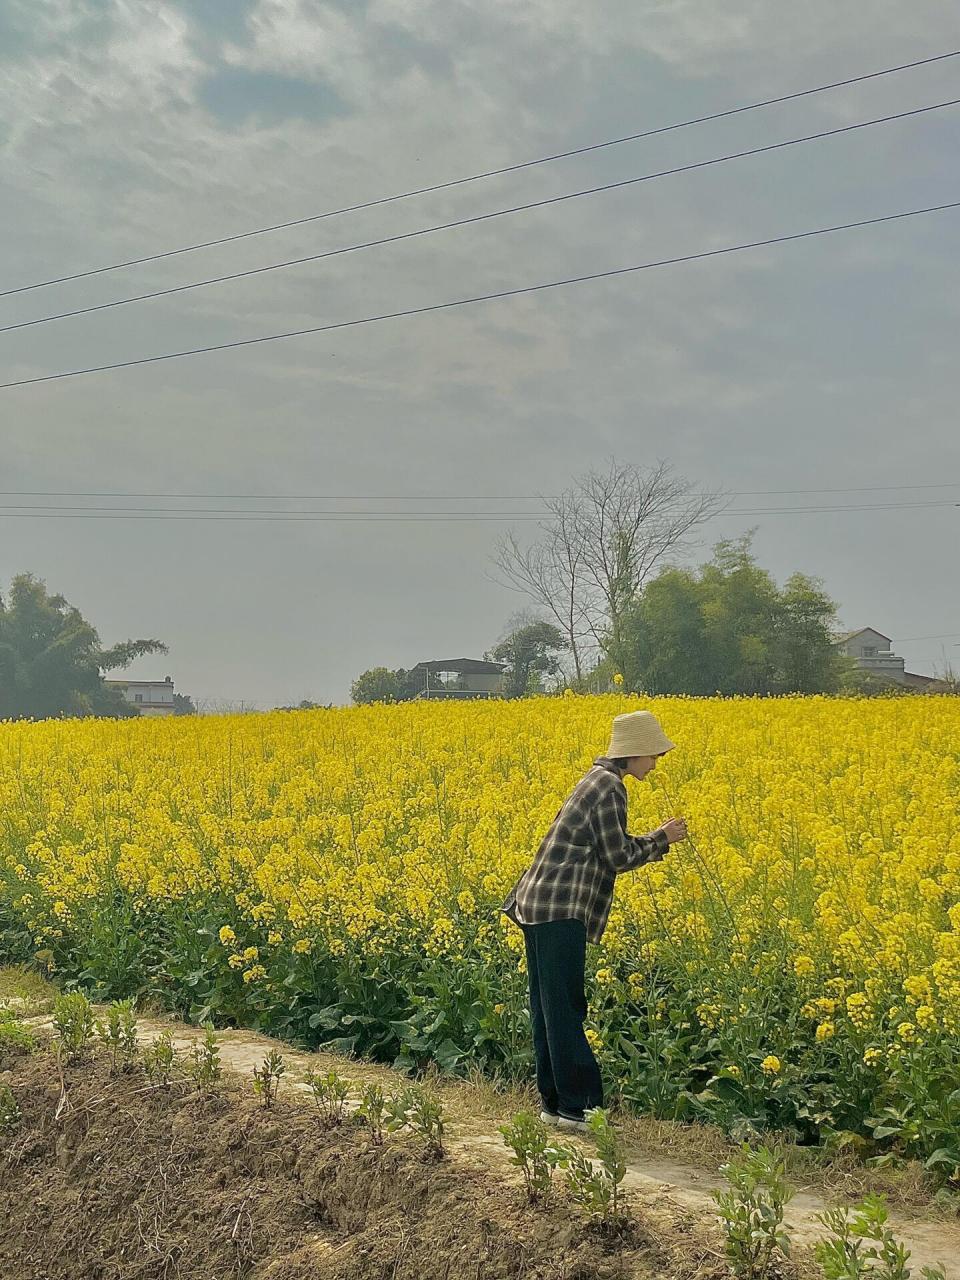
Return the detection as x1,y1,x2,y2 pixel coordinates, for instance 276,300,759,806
0,573,166,719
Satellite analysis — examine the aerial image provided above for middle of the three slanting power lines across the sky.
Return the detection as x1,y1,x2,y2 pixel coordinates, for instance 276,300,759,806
7,97,960,333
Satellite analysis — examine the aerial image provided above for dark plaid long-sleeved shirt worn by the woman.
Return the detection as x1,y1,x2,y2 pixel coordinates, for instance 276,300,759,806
502,756,669,942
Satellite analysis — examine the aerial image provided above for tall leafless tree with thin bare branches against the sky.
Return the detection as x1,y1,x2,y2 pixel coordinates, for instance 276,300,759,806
494,460,726,678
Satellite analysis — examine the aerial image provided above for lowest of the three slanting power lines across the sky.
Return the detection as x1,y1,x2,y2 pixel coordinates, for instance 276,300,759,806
0,200,960,390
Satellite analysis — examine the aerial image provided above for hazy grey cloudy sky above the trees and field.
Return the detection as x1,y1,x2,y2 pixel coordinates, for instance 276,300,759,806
0,0,960,708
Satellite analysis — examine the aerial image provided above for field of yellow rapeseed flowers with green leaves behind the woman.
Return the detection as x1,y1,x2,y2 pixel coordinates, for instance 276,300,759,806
0,695,960,1169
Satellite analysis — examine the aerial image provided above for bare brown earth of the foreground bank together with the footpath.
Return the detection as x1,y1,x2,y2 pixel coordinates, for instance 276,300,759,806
0,970,960,1280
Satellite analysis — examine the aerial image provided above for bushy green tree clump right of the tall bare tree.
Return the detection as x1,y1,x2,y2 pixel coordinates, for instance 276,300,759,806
623,534,844,695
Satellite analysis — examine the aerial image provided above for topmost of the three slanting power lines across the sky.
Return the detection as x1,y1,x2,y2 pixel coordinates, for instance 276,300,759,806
0,49,960,297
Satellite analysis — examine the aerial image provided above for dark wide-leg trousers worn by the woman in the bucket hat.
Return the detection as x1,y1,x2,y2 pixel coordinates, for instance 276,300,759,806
522,920,603,1119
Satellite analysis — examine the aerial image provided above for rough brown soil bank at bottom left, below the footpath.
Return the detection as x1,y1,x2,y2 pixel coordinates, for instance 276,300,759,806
0,1052,726,1280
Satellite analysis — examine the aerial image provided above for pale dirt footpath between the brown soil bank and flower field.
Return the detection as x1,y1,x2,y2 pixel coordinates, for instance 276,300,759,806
26,1016,960,1280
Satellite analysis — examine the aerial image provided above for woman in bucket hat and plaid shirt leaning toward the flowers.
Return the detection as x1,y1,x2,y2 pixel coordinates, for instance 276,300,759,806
503,712,687,1130
